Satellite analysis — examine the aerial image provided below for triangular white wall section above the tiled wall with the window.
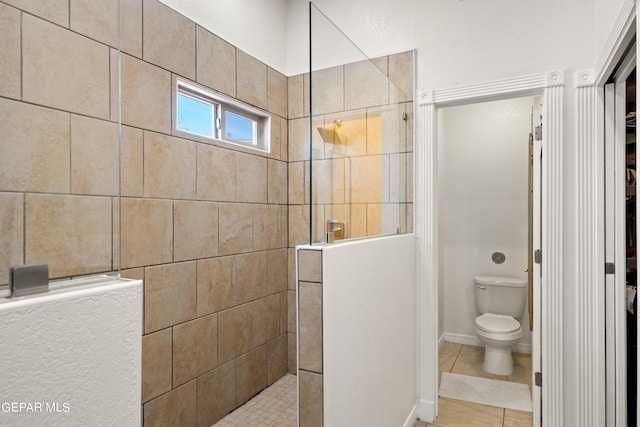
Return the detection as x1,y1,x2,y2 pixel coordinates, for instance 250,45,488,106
160,0,287,75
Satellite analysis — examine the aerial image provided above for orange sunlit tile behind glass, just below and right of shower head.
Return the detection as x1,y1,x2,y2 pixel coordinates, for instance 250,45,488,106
346,156,383,203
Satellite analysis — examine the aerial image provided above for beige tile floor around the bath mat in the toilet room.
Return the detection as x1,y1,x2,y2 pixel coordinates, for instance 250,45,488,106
414,343,533,427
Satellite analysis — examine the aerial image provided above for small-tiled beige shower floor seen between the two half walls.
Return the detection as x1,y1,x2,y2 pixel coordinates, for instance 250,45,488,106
213,374,297,427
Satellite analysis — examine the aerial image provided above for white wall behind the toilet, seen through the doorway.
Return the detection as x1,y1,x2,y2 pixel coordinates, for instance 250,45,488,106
438,97,533,352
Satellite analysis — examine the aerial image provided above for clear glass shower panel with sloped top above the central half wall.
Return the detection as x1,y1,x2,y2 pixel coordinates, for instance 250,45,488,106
305,4,413,244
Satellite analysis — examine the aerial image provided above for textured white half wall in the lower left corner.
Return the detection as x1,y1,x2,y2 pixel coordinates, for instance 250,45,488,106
0,278,142,427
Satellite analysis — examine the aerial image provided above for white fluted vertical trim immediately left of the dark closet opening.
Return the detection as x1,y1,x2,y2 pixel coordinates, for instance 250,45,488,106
575,70,606,427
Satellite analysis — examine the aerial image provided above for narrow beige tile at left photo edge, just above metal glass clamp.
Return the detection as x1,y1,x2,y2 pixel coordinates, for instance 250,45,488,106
0,193,24,286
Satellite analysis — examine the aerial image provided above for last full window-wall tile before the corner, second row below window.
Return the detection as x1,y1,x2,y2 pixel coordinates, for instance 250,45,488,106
253,205,287,251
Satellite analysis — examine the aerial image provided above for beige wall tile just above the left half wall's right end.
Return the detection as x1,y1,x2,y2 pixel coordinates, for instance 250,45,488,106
122,199,173,268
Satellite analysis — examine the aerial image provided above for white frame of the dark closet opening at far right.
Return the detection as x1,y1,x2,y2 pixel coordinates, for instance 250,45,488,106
596,5,640,427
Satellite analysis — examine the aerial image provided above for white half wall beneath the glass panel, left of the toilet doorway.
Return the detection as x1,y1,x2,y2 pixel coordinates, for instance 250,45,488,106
322,235,417,427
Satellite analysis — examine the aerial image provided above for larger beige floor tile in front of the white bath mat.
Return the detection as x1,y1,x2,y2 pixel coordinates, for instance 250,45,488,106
435,397,504,427
